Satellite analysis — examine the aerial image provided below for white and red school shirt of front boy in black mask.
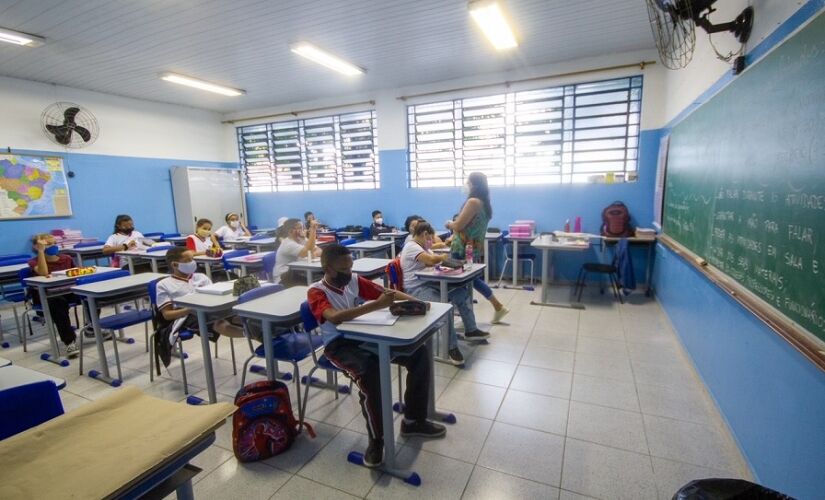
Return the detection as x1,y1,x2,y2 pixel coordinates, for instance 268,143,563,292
307,274,384,345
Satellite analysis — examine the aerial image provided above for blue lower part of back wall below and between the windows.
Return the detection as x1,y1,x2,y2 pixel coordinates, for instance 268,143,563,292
246,130,660,279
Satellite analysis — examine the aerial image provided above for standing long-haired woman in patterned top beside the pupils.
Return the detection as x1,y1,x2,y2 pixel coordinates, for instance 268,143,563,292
446,172,510,324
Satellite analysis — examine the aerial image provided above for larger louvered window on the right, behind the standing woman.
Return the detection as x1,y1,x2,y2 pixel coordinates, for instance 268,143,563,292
407,76,642,187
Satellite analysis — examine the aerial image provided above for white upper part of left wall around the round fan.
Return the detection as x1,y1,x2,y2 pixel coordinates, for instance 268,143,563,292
0,77,232,162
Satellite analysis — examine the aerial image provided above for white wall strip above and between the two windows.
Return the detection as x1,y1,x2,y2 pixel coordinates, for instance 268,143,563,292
224,51,665,150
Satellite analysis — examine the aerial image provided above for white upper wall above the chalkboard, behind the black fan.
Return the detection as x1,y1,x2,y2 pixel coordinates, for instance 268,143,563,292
664,0,806,123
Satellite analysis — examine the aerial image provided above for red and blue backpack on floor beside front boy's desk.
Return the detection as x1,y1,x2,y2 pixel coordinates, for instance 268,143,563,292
232,380,315,462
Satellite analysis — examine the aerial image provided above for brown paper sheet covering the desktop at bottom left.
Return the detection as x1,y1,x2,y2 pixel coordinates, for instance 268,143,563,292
0,387,235,499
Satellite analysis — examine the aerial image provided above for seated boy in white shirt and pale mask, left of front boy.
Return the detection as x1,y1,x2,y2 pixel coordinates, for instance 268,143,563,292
155,246,218,366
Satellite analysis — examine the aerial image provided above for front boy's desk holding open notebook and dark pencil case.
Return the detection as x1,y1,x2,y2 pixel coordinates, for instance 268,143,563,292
340,300,458,486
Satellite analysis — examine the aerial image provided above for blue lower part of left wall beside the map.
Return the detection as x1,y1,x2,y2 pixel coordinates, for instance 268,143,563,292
0,151,237,254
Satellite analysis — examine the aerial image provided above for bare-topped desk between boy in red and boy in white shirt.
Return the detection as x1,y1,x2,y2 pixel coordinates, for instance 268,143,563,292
72,273,168,387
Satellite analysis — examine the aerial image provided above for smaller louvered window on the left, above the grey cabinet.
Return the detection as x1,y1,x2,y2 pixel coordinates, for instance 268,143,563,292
237,111,380,192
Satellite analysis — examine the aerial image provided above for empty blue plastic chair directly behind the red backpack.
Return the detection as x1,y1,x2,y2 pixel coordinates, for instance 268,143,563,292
238,285,324,425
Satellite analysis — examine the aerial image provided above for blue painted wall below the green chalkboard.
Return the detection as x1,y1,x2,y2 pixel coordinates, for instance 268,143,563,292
654,245,825,499
